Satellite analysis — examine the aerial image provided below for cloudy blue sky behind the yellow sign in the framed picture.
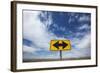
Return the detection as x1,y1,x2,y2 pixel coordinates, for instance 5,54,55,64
23,10,91,59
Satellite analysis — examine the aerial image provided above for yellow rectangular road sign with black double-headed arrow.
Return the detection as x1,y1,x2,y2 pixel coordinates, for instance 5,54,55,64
50,40,71,51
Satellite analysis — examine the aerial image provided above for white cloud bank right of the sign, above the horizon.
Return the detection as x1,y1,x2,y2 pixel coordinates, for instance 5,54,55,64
63,34,91,58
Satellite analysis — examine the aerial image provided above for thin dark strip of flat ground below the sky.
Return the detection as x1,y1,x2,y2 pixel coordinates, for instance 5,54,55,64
23,57,91,62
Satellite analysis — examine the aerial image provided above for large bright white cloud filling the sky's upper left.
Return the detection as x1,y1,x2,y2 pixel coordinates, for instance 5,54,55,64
23,11,55,49
